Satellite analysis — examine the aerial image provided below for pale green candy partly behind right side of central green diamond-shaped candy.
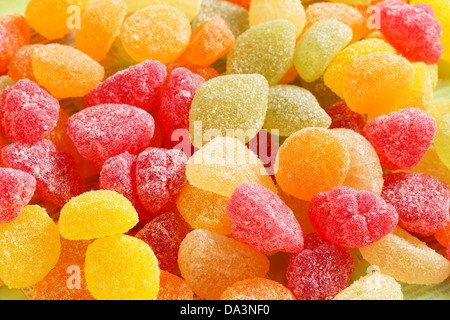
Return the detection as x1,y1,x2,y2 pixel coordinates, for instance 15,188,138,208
263,84,331,137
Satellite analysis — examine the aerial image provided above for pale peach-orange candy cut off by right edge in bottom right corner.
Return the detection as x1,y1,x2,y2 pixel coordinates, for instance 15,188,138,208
359,227,450,285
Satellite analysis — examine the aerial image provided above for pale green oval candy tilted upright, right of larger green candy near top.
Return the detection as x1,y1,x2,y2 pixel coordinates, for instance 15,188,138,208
294,19,353,82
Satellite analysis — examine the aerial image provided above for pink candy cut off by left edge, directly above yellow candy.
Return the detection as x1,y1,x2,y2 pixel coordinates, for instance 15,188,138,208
0,168,36,223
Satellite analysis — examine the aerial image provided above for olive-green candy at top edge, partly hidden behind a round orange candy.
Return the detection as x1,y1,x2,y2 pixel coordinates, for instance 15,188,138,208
192,0,250,38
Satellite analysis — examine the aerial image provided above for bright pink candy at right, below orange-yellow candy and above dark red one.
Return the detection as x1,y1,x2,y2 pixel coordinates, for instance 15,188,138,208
364,108,437,170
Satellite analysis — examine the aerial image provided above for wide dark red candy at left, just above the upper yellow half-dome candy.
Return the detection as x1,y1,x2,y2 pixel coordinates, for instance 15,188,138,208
2,139,83,208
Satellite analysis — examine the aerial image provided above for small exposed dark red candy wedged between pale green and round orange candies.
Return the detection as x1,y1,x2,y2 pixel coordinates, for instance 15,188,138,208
325,101,366,134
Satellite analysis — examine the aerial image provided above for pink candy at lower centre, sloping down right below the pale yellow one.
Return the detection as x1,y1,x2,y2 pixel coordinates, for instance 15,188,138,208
227,183,303,253
